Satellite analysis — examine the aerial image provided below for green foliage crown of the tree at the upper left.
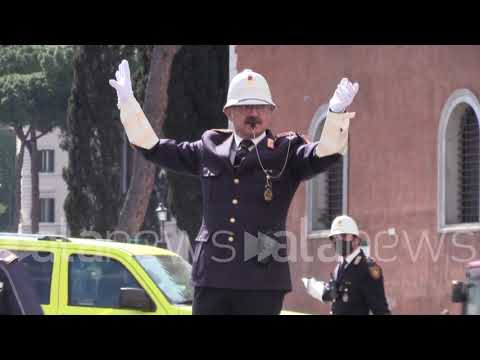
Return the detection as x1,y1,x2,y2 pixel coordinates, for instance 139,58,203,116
0,45,73,132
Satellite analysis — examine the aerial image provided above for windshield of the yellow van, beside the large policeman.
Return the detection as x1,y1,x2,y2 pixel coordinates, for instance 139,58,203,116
135,255,193,305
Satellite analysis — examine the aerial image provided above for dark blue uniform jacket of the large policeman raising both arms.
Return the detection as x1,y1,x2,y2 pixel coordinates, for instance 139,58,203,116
137,130,341,291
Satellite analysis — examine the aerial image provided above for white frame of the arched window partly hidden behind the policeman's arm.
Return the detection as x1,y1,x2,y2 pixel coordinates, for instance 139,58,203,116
305,104,348,239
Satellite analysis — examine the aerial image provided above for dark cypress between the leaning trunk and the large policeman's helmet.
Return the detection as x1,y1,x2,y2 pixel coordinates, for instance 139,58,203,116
163,45,229,241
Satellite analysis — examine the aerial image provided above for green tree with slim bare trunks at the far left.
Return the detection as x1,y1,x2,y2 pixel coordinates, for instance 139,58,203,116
0,45,72,233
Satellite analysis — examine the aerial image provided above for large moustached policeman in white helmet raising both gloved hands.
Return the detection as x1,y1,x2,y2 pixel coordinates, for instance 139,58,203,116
110,60,358,314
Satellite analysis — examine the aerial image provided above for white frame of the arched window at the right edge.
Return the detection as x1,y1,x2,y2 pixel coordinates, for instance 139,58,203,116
437,89,480,233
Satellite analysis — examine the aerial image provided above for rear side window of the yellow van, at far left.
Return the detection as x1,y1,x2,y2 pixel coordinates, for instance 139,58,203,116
11,250,53,305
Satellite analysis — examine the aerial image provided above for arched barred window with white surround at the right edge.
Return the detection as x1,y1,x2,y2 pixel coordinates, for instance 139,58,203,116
438,89,480,231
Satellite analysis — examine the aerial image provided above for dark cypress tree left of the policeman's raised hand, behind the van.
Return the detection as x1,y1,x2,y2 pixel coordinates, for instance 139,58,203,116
62,45,142,237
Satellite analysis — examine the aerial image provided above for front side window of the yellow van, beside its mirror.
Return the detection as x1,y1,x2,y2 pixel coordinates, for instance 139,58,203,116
68,255,141,308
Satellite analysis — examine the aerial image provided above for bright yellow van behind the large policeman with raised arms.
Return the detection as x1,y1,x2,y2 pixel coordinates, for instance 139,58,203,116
0,234,304,315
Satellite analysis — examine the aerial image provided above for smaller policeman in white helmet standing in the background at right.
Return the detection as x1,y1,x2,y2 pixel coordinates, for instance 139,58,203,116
303,215,390,315
